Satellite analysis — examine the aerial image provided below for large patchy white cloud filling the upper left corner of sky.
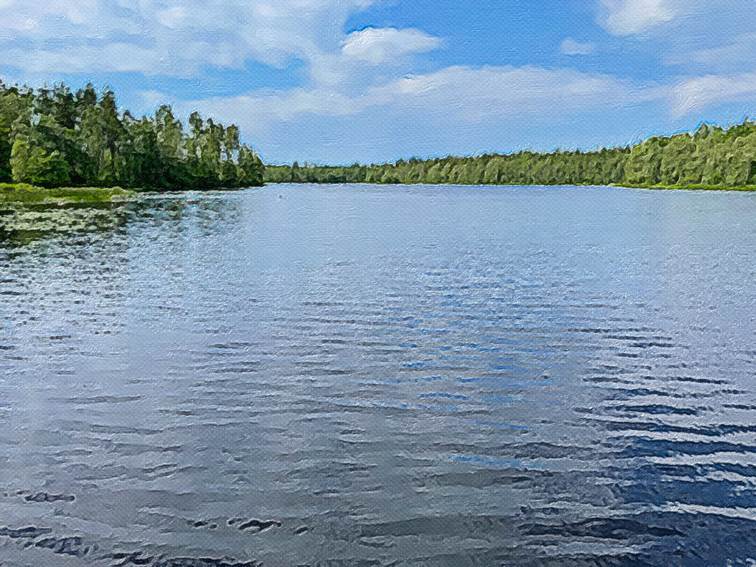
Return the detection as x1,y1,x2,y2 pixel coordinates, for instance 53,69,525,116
0,0,373,76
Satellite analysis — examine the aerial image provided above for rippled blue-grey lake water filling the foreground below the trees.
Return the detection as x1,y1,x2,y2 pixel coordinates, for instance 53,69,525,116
0,186,756,567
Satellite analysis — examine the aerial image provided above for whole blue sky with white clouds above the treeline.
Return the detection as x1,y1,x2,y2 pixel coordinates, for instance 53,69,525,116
0,0,756,163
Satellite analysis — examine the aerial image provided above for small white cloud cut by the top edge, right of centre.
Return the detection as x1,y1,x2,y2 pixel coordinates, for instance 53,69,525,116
601,0,678,35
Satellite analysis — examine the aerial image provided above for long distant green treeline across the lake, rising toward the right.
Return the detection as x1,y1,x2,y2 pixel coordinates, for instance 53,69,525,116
265,120,756,188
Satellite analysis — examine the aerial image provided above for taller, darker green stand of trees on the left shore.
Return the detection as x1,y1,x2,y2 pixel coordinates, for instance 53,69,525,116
0,83,264,189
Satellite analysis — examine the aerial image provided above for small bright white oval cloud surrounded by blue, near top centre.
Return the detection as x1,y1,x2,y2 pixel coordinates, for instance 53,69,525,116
342,28,441,65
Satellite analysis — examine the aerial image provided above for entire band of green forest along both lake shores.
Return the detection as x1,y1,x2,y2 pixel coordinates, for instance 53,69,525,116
0,82,756,190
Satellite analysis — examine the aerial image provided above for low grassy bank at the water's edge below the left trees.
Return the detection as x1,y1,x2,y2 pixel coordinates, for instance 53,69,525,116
0,183,133,205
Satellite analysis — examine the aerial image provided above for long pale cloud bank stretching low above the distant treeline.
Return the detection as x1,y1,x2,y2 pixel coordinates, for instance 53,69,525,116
186,60,756,159
